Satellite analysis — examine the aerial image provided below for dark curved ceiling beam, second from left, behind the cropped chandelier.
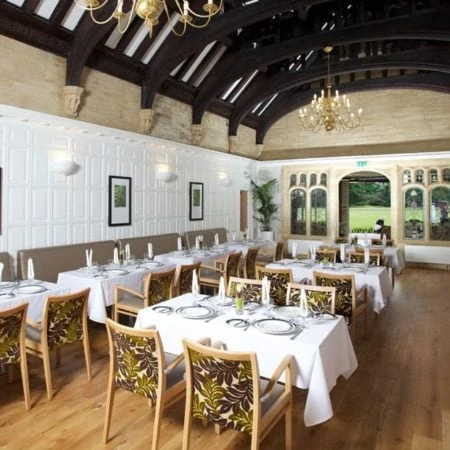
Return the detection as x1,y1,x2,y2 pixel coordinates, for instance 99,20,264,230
142,0,330,108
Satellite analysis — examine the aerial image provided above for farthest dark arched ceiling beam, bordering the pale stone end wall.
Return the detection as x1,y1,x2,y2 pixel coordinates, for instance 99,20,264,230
256,73,450,144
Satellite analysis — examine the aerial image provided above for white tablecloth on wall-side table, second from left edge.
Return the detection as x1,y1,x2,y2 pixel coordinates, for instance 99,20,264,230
58,264,174,323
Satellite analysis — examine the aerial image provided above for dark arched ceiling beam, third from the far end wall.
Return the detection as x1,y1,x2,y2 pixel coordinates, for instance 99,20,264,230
193,13,450,123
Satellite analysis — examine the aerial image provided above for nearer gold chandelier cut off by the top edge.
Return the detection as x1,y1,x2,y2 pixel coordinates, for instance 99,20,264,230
75,0,223,38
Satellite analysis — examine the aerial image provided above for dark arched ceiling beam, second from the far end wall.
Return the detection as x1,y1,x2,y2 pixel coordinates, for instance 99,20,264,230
229,46,450,136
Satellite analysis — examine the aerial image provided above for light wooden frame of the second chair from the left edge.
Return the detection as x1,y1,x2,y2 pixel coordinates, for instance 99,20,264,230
25,288,92,400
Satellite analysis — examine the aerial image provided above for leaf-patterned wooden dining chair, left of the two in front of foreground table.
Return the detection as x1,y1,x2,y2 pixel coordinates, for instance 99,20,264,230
103,319,190,450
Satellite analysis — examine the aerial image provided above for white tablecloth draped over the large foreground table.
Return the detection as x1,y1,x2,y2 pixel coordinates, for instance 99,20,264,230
135,294,358,426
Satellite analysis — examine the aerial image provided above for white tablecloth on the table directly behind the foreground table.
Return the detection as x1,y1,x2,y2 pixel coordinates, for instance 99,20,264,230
267,259,392,313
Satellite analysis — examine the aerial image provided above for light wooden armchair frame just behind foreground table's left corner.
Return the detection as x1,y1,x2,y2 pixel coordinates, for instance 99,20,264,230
114,268,176,322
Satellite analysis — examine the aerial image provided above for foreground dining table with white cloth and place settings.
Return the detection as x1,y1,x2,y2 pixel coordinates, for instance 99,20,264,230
135,293,358,426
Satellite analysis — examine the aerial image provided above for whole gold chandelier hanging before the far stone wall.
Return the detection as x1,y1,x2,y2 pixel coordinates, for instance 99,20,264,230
298,46,362,133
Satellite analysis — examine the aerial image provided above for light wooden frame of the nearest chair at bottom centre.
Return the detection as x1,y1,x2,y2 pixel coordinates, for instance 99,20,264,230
183,338,293,450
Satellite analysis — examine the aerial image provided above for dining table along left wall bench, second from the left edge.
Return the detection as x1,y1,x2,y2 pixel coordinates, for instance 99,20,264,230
57,260,175,323
